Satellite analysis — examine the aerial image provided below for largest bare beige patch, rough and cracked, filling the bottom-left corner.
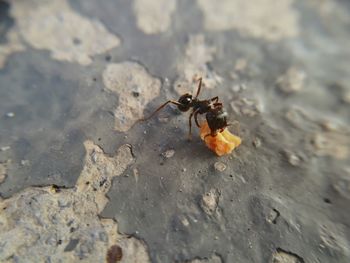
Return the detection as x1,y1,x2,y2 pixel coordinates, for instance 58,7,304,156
0,141,150,262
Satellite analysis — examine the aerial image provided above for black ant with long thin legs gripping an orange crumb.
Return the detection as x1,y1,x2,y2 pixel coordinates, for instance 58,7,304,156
139,78,229,140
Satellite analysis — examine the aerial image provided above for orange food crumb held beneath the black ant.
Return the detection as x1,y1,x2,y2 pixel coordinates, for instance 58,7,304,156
200,122,242,156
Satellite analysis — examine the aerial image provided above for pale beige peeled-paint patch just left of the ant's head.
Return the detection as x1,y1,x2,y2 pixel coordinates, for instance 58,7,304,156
103,62,161,132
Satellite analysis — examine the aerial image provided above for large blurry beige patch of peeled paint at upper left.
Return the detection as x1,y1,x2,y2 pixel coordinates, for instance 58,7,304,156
7,0,120,66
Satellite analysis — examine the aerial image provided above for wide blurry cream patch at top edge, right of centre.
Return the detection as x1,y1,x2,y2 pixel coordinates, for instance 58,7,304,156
197,0,299,41
